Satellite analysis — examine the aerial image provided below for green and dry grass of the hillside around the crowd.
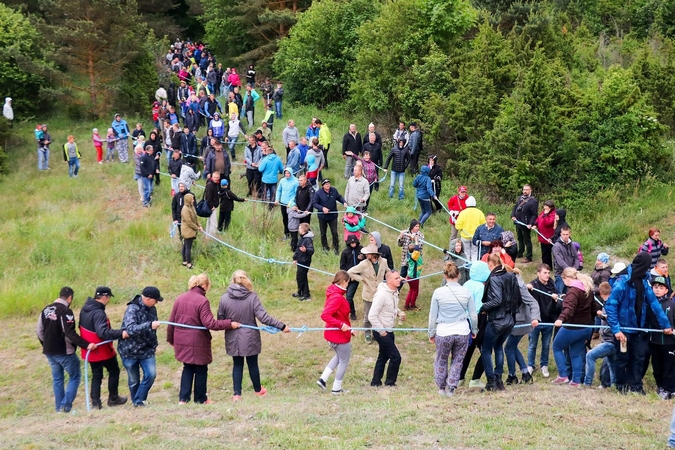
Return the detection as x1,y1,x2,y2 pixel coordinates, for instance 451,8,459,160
0,108,675,449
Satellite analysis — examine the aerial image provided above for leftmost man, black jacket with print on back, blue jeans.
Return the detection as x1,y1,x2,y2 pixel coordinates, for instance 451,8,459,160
36,286,96,413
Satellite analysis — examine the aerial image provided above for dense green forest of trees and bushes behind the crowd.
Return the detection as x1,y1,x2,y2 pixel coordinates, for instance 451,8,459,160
0,0,675,196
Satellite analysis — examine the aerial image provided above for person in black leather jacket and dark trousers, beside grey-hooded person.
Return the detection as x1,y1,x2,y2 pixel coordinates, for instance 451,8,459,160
480,253,523,391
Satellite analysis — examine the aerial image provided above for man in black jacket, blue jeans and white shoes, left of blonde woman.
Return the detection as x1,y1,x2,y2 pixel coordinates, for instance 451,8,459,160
527,264,561,378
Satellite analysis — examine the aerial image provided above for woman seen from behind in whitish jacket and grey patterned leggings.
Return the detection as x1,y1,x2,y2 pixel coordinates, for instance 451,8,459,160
429,262,478,397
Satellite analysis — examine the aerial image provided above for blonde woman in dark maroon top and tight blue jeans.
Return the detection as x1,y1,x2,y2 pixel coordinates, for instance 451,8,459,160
552,267,598,386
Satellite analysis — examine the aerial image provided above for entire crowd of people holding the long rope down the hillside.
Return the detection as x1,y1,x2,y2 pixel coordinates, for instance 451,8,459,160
27,41,675,446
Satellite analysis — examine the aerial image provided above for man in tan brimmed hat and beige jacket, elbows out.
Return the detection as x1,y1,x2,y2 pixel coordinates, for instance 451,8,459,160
347,244,391,344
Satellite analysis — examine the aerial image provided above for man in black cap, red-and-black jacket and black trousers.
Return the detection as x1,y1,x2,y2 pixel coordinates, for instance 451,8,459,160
80,286,129,409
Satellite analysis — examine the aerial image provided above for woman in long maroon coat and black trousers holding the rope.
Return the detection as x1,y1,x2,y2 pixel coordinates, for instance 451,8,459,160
166,273,239,405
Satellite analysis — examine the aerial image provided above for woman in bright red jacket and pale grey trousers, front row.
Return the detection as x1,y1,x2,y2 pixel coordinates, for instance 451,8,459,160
316,270,353,394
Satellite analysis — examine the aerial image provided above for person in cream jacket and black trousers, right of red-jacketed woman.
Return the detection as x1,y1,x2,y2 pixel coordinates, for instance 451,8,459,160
368,270,405,387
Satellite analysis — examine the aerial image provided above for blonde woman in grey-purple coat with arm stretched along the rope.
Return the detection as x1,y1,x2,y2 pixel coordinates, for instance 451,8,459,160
218,270,291,401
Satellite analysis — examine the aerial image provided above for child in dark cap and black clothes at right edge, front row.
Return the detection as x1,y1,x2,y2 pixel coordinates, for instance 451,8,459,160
645,276,675,400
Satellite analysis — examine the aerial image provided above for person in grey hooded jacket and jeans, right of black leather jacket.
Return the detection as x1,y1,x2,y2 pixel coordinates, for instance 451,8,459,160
504,266,541,385
